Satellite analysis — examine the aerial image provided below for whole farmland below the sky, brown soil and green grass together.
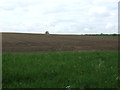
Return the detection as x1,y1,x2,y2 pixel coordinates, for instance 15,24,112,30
2,33,118,88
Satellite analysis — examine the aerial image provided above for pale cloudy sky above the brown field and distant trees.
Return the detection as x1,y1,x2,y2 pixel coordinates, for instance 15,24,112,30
0,0,119,34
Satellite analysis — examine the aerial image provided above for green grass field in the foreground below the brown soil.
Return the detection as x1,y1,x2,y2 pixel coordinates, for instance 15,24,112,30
3,52,118,88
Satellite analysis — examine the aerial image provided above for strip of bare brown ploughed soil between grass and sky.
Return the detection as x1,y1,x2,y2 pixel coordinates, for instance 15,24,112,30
2,33,118,52
